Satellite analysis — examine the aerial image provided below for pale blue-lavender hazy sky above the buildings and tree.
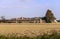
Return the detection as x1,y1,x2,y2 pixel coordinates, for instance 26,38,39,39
0,0,60,19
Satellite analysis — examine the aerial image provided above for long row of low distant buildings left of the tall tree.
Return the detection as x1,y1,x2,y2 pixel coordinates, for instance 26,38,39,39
0,17,45,23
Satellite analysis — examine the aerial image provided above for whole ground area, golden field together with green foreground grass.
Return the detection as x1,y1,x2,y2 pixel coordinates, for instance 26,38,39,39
0,23,60,39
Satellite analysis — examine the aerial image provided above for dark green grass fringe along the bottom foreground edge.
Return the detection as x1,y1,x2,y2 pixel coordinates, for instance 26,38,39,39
0,30,60,39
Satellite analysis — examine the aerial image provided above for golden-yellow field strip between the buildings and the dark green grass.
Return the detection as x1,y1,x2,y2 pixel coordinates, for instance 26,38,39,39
0,23,60,35
